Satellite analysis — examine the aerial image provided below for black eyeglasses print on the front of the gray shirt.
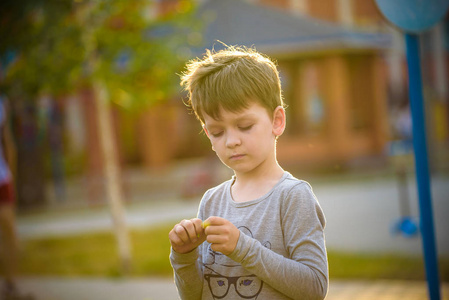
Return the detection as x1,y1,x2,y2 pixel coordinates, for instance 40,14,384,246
204,274,263,299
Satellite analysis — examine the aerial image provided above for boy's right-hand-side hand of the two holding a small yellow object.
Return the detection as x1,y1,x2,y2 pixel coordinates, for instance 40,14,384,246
203,217,240,255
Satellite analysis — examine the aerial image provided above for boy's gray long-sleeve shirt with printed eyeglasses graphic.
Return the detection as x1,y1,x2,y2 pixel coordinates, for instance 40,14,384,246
170,172,328,299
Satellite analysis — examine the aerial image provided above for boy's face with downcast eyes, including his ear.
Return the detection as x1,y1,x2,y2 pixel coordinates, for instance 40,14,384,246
204,102,285,175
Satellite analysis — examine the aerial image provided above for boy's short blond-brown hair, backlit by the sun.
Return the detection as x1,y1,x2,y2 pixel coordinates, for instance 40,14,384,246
181,46,284,124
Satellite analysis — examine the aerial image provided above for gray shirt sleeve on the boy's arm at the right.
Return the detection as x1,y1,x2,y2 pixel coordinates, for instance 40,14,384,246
229,183,328,299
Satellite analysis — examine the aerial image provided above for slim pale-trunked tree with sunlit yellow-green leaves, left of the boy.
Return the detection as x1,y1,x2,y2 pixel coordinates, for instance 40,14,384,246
80,0,199,270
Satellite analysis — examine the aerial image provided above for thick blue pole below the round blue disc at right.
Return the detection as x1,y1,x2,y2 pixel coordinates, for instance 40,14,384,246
405,33,440,300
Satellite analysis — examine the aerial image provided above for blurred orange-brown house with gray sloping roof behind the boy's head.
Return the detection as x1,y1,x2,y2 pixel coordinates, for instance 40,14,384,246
136,0,391,166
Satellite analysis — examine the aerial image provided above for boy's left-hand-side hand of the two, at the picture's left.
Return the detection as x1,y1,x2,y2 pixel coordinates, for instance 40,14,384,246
168,218,206,254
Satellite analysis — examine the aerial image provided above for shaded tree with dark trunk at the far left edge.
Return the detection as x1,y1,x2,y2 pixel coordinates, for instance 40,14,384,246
0,0,83,207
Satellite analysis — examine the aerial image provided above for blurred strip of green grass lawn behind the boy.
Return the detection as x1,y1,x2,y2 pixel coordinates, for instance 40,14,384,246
5,225,449,282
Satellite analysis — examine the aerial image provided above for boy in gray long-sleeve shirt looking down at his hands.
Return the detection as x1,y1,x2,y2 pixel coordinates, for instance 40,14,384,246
169,47,328,299
